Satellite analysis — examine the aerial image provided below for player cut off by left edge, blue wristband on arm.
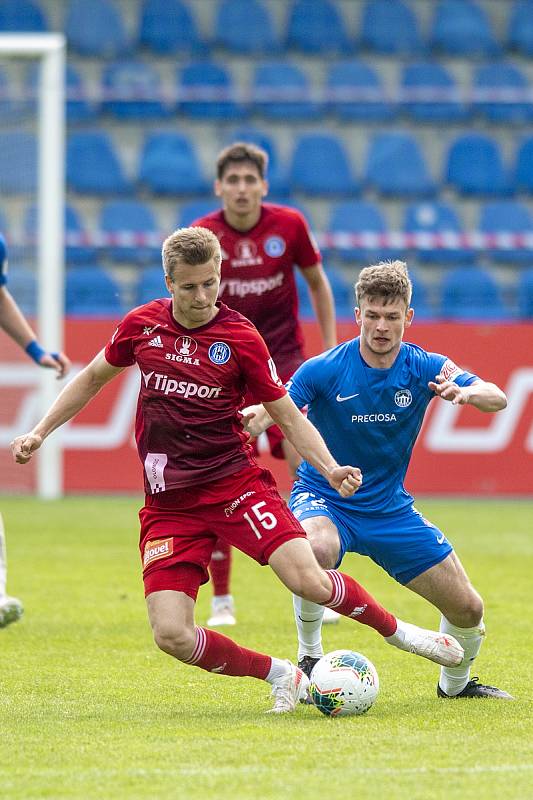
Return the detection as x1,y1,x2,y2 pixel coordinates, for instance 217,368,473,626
0,235,70,628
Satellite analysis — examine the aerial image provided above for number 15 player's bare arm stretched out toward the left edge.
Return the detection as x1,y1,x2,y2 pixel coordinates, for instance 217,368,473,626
11,350,124,464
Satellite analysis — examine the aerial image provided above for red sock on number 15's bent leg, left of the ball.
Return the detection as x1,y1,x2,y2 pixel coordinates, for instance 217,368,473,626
185,627,272,680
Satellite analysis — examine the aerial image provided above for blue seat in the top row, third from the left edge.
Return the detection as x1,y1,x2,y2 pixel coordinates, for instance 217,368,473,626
140,0,206,56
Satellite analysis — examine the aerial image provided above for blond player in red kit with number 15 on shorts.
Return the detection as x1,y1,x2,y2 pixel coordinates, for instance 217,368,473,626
12,228,463,713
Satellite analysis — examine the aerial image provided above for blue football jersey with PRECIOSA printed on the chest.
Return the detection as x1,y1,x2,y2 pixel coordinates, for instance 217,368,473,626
287,338,477,513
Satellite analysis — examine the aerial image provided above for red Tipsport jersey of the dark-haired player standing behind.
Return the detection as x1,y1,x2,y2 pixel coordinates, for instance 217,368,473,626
193,203,321,379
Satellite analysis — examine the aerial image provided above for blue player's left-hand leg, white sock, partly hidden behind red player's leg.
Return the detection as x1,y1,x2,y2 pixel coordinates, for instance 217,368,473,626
293,512,340,675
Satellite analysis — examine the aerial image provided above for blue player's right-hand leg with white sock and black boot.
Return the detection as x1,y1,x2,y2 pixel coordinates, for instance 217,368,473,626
406,551,512,700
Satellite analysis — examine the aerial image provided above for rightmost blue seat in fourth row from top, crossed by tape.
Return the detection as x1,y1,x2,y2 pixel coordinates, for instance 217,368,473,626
478,200,533,266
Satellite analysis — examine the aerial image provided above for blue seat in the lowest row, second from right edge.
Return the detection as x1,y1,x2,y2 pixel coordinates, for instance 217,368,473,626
440,265,507,320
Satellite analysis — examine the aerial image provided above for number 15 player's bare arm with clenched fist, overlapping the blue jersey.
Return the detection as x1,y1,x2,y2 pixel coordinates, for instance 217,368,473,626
263,395,363,497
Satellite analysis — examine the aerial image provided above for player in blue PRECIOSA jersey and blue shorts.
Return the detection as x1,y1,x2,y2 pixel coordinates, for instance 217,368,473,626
248,261,512,699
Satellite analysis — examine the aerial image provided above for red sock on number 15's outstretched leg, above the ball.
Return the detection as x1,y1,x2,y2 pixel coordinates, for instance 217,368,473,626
324,569,397,636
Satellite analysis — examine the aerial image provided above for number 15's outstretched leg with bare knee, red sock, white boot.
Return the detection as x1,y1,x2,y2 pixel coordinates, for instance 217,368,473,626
269,538,464,665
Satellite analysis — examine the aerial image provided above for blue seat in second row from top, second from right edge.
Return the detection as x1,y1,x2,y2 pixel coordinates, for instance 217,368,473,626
401,61,470,123
